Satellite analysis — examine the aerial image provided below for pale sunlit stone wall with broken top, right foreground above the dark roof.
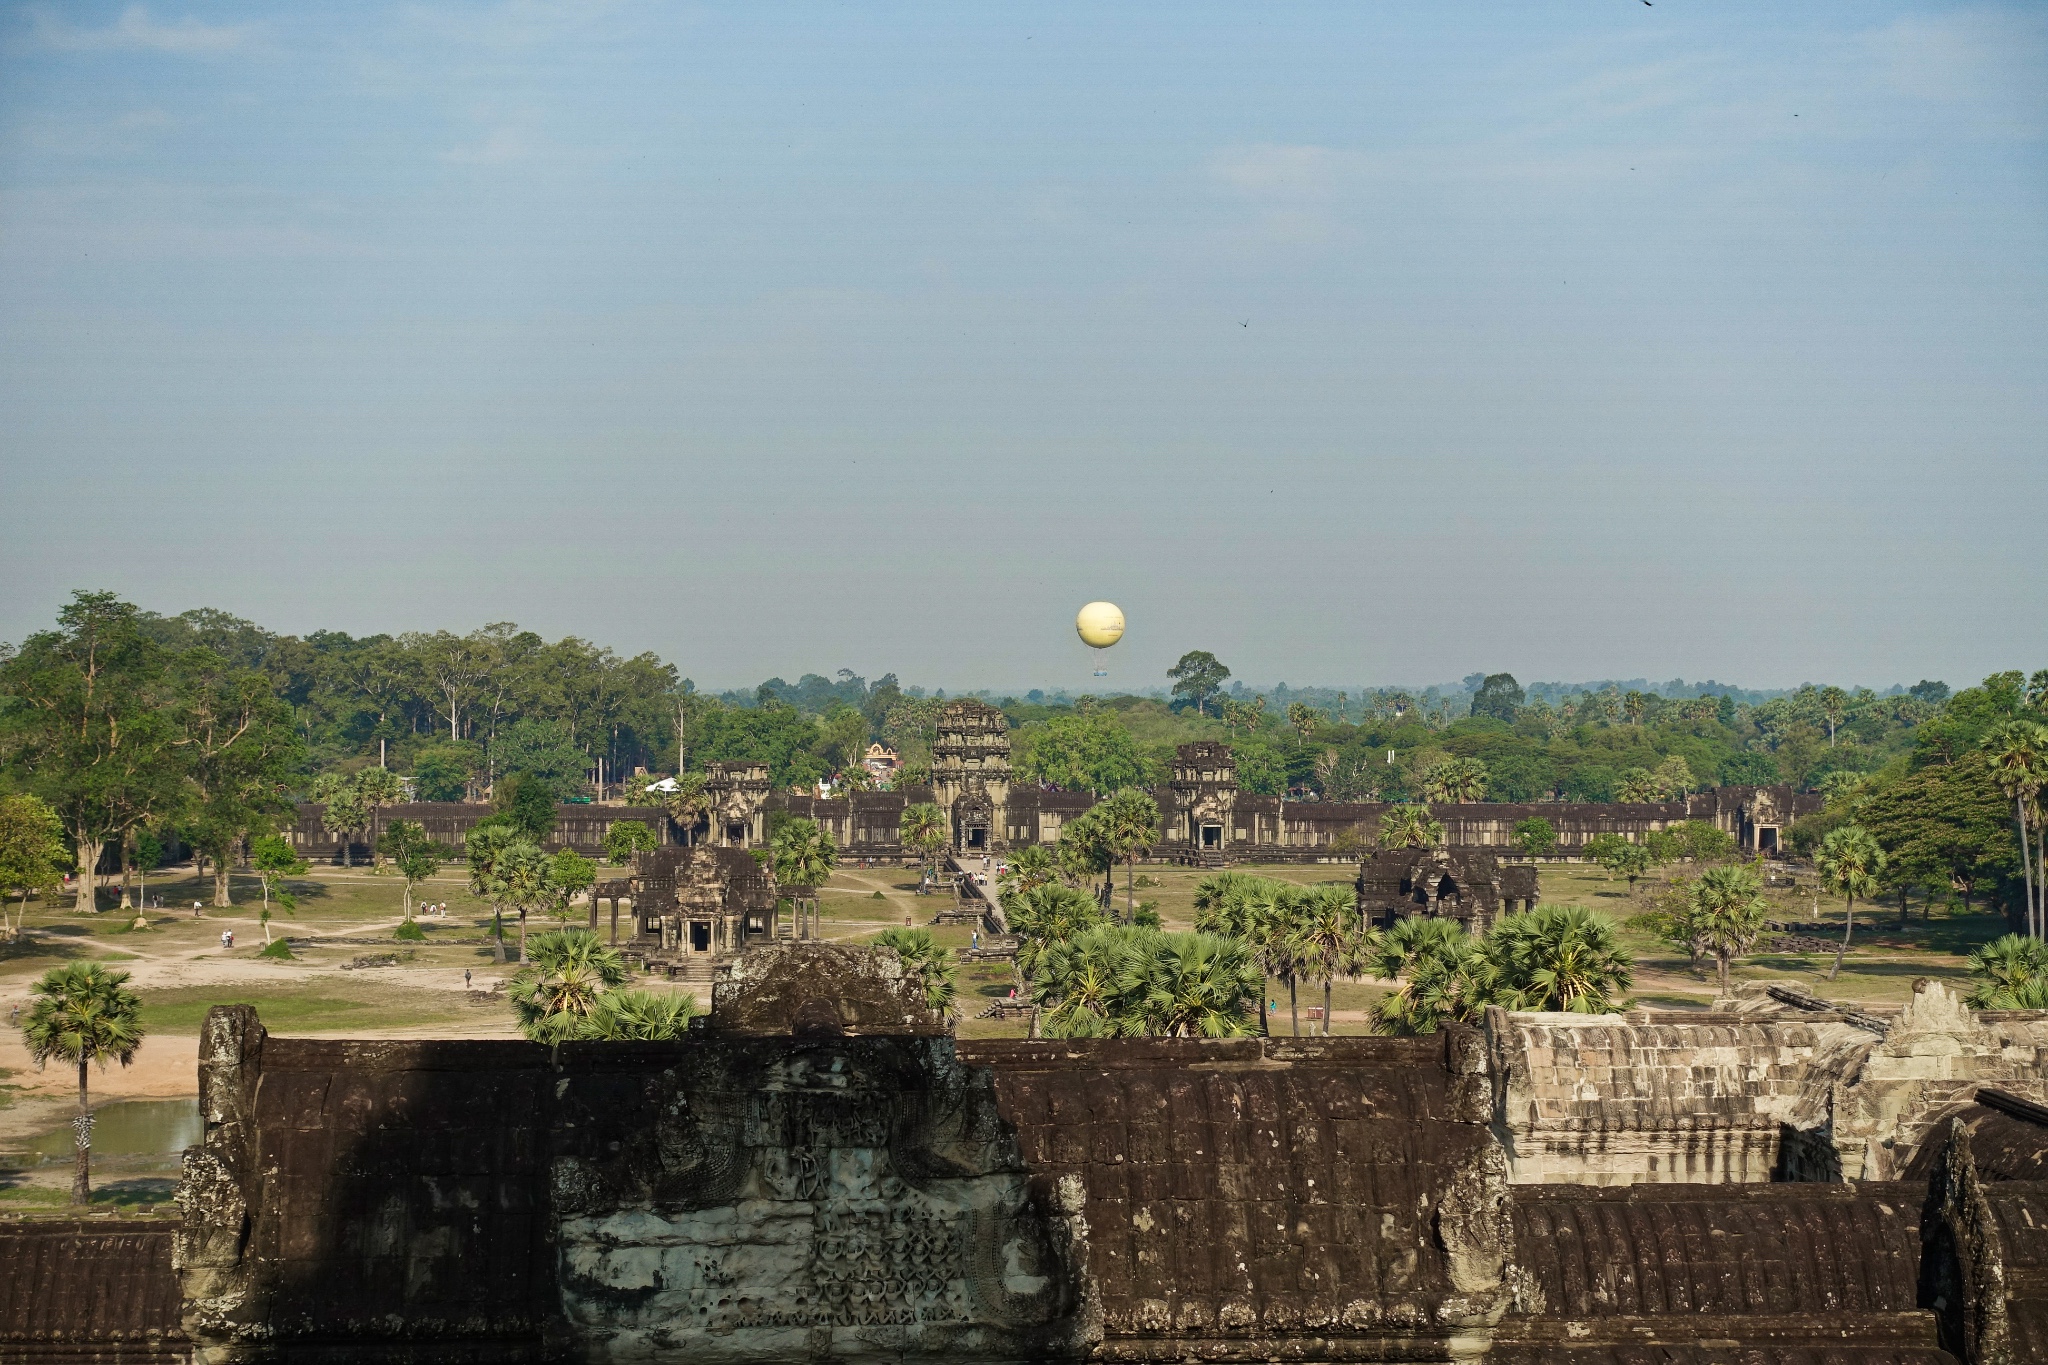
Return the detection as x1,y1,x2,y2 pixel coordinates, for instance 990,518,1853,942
1487,980,2048,1185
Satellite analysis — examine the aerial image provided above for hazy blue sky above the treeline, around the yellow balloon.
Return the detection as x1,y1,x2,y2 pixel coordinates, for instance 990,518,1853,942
0,0,2048,688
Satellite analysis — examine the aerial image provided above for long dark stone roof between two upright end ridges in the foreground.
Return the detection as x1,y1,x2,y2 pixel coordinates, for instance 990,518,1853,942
167,1007,1507,1361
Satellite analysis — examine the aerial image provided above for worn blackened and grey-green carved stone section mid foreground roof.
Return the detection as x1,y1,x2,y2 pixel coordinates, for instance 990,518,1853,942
553,1038,1083,1361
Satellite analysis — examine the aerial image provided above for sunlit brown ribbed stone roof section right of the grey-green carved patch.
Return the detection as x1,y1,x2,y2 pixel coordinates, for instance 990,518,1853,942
961,1029,1507,1361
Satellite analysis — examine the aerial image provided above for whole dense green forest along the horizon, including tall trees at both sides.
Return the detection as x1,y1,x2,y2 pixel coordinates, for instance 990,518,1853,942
0,593,2048,929
